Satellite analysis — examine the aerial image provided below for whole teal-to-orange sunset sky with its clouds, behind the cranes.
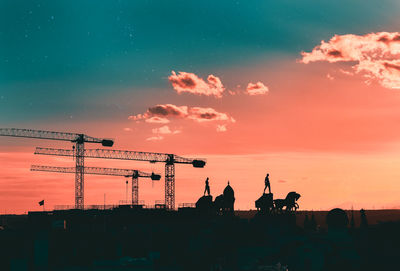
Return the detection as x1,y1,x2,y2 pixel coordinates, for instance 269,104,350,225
0,0,400,213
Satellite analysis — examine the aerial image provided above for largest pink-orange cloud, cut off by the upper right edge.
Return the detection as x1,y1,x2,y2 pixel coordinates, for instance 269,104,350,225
300,32,400,89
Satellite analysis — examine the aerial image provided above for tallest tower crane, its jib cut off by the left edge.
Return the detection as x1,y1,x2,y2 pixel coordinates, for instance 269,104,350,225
0,128,114,209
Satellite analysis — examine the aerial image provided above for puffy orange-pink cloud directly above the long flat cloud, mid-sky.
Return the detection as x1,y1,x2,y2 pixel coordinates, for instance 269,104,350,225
168,71,225,98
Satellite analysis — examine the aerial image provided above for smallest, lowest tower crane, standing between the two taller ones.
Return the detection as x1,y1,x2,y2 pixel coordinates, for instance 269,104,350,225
31,165,161,205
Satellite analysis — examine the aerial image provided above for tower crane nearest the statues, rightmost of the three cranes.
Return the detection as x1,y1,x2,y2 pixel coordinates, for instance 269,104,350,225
35,147,206,210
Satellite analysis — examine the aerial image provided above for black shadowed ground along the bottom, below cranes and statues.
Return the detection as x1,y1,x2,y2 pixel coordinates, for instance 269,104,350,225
0,206,400,270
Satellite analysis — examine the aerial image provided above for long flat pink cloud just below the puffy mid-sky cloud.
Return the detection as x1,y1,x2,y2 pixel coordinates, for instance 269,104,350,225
129,104,236,123
